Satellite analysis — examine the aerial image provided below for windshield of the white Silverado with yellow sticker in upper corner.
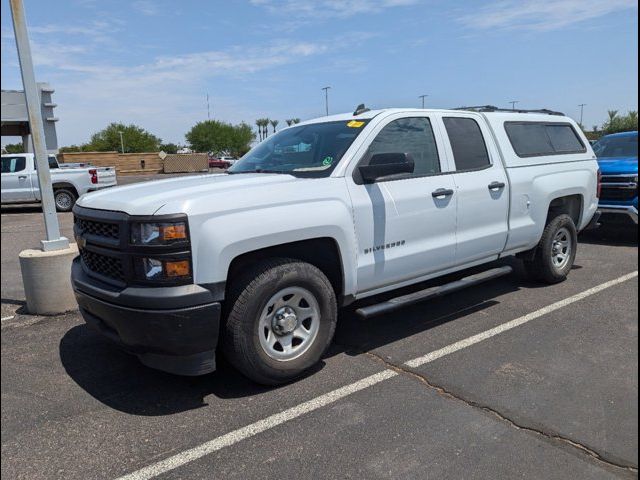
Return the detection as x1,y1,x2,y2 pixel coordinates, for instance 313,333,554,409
228,120,367,177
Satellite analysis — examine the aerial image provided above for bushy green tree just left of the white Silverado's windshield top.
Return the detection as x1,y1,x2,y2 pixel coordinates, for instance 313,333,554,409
185,120,254,155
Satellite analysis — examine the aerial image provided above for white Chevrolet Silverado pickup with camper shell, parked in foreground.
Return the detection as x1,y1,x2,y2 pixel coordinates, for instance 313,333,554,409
72,107,599,384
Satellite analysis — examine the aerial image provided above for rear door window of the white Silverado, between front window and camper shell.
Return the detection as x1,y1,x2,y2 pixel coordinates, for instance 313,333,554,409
442,117,491,171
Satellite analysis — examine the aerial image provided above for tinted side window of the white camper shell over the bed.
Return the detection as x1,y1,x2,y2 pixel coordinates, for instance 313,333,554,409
504,122,586,157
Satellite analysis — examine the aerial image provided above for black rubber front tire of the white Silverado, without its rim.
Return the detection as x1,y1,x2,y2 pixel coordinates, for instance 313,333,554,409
222,258,338,385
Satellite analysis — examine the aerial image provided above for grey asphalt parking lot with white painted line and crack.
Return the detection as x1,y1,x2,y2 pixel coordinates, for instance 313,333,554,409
2,178,638,479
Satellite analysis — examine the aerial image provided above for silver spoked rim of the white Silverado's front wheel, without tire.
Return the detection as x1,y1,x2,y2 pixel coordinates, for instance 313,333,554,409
258,287,320,361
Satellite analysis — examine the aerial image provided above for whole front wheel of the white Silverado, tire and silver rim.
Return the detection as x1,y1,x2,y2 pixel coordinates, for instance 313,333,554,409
222,259,337,385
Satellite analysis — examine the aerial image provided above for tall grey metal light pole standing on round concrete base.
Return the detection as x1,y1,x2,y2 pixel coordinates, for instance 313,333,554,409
10,0,69,251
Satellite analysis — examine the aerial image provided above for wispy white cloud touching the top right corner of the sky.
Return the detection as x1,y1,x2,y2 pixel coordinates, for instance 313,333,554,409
458,0,638,31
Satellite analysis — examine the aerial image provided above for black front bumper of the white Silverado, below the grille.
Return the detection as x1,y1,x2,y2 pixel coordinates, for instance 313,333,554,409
71,258,221,375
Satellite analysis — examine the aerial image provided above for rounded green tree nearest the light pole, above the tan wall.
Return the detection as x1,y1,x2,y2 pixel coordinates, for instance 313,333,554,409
83,123,162,153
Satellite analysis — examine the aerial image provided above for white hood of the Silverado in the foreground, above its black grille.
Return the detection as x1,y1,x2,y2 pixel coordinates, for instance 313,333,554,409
78,173,303,215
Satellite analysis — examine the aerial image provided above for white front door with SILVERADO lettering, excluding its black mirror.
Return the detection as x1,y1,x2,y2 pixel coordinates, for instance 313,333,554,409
346,113,457,293
